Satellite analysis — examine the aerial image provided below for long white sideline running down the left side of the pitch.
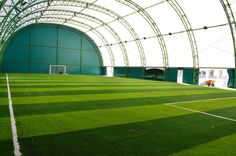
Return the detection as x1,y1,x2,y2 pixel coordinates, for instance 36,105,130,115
6,74,21,156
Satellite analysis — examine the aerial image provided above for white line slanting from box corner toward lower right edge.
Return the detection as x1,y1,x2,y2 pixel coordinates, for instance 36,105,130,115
164,104,236,122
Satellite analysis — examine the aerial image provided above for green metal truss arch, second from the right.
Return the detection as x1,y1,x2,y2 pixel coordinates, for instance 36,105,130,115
167,0,199,84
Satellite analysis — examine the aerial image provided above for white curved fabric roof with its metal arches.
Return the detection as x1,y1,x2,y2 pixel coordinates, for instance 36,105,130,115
0,0,236,68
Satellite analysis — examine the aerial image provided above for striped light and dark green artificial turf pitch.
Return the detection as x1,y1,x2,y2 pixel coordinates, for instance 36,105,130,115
0,74,236,156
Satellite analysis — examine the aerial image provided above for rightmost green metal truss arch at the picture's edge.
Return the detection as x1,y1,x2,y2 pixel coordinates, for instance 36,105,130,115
220,0,236,88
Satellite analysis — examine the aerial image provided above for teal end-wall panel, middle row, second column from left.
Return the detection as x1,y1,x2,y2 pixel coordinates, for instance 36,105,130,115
31,46,57,64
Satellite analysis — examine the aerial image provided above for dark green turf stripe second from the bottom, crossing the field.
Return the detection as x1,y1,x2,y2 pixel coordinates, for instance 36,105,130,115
0,92,236,117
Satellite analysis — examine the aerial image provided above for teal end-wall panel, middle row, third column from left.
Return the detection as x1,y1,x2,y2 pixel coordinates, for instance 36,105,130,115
58,48,81,66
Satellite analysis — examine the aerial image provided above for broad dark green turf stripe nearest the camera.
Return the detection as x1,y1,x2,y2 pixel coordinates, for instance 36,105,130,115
20,111,236,156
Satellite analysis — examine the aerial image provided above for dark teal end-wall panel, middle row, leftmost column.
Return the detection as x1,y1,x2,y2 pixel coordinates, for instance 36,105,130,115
4,43,29,63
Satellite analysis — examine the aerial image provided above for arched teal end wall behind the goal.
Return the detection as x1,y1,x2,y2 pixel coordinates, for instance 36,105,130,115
2,24,102,75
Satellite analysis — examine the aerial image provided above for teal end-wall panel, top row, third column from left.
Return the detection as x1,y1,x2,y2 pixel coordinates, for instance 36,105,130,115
58,29,81,49
